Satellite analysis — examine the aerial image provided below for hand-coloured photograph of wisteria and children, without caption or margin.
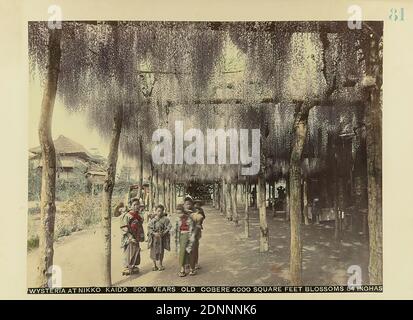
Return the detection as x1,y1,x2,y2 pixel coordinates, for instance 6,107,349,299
27,20,384,288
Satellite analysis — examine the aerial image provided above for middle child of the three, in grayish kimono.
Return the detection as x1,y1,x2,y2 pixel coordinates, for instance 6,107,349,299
148,205,172,271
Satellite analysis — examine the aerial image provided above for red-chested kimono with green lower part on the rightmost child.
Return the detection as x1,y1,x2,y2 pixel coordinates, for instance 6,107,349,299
174,214,195,267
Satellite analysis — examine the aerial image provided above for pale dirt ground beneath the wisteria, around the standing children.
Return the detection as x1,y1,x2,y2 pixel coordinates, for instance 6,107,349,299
28,206,368,287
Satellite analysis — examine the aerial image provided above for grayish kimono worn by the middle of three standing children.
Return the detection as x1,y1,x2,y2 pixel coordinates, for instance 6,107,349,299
148,215,172,261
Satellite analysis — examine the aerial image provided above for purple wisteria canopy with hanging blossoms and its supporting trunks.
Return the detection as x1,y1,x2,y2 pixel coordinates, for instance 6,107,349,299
29,21,382,286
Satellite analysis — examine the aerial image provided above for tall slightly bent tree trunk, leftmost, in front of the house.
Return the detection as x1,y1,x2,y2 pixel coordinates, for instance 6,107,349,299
37,29,62,287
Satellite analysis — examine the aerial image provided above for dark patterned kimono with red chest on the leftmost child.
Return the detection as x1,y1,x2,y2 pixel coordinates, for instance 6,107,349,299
120,211,145,269
